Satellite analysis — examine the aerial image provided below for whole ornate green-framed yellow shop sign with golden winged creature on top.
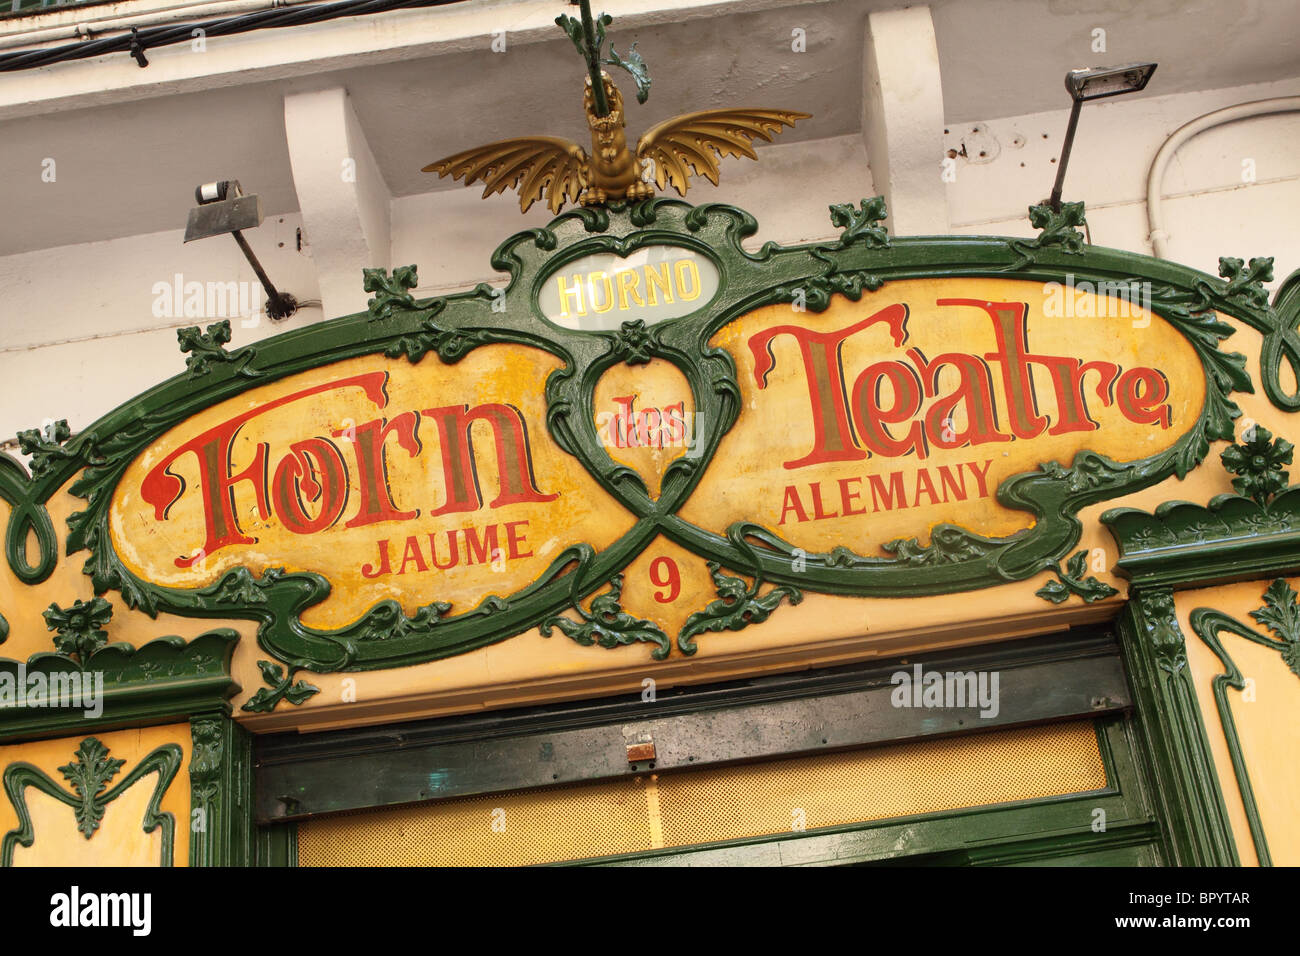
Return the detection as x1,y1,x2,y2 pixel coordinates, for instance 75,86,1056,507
0,5,1300,710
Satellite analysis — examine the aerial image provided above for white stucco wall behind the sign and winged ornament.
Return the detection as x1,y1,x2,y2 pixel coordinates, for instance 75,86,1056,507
0,4,1300,451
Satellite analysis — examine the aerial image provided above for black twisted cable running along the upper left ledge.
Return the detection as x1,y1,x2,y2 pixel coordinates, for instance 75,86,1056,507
0,0,464,73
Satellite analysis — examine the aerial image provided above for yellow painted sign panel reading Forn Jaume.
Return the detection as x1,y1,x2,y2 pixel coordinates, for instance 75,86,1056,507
109,345,633,627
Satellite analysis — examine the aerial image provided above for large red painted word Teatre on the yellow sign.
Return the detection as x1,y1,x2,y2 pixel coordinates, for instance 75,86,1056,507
749,299,1173,468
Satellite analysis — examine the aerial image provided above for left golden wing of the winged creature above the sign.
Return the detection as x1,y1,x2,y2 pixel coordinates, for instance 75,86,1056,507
423,137,588,212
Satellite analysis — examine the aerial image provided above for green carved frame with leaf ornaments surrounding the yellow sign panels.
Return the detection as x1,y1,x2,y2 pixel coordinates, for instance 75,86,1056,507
0,198,1300,710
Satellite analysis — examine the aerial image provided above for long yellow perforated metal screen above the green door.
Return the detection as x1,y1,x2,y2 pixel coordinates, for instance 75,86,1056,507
298,721,1106,866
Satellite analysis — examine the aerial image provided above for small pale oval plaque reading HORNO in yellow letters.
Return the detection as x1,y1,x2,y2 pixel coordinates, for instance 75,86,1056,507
537,246,719,332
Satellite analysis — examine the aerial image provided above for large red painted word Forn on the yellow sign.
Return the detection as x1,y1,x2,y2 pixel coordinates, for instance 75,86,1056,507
140,372,559,567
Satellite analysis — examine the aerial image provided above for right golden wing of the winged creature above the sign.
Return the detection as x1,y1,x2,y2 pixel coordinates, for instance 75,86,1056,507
637,109,810,195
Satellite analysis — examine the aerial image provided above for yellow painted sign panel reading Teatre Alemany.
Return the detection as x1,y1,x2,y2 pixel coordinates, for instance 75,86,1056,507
681,278,1205,553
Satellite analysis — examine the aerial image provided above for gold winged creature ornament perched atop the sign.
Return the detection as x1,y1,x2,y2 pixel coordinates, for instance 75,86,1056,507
424,70,809,212
